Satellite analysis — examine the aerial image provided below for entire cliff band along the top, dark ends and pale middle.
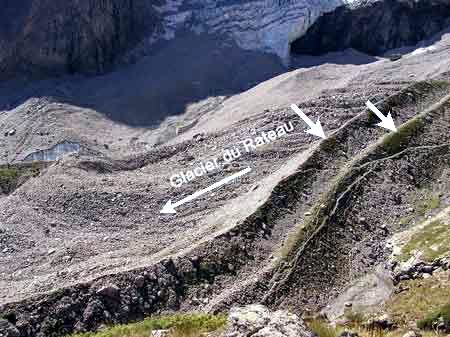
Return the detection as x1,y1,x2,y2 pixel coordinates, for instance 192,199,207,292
0,0,450,79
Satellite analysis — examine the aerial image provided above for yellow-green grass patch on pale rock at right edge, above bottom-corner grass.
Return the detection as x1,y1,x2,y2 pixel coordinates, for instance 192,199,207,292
398,220,450,262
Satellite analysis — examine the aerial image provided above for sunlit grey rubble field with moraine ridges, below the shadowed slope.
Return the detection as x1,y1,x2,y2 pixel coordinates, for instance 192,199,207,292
0,30,450,336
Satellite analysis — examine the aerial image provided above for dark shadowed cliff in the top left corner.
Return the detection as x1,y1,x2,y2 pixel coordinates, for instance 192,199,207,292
0,0,159,79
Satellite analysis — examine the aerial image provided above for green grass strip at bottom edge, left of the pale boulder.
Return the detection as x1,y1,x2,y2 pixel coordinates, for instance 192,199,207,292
67,314,227,337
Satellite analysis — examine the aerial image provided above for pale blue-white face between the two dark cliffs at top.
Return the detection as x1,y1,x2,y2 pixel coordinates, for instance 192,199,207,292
152,0,353,62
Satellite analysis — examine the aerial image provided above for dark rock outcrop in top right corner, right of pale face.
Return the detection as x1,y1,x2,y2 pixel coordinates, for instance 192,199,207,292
291,0,450,55
